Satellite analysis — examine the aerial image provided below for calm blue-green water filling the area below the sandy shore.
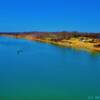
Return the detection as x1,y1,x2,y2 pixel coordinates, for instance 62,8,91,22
0,37,100,100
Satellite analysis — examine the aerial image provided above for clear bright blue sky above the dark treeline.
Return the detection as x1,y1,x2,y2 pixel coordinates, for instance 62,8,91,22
0,0,100,32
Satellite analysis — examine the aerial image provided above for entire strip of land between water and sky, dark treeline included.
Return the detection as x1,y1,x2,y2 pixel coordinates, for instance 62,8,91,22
0,31,100,52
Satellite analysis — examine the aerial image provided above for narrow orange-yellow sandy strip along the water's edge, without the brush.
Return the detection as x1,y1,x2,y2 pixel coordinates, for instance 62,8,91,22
0,35,100,52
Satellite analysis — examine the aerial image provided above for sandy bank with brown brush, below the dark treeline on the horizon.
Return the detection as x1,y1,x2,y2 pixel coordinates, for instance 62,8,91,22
2,33,100,52
